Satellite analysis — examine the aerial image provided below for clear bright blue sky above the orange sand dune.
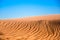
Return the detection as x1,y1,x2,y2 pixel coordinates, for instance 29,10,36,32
0,0,60,19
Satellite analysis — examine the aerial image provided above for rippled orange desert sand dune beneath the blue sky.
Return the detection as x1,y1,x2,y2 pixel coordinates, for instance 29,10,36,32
0,14,60,40
